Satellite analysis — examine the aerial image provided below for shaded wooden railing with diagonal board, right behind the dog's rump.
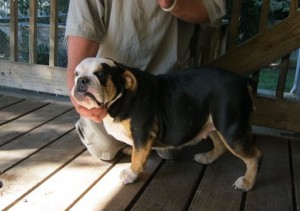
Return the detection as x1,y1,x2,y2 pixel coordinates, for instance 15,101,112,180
211,0,300,132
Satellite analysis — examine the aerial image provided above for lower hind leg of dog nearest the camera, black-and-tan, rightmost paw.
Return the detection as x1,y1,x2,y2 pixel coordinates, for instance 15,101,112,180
219,130,262,191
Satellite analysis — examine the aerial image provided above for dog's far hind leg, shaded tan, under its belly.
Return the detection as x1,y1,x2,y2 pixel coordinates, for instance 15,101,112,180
194,131,227,164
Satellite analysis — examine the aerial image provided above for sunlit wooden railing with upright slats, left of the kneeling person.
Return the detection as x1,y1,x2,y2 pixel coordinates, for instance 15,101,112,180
0,0,68,95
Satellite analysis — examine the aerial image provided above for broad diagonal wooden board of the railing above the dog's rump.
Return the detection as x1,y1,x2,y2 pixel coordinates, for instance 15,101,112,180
211,13,300,75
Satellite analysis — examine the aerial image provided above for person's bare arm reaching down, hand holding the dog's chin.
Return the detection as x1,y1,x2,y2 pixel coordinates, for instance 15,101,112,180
67,36,106,122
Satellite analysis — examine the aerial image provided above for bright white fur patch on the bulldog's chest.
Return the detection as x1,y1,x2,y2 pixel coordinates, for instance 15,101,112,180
103,114,133,146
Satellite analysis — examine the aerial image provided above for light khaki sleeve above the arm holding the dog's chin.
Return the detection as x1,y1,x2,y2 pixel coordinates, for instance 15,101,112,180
65,0,108,43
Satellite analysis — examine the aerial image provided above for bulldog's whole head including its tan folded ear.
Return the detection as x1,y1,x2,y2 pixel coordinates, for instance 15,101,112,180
71,58,137,109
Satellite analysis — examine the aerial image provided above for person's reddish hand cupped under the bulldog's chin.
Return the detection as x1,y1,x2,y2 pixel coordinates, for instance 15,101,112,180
71,97,107,123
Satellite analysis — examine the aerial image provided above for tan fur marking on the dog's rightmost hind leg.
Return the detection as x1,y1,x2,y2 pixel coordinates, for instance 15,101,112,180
218,131,262,191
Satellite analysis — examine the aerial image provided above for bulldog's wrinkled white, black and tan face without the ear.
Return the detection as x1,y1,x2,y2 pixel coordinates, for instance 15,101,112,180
71,58,117,109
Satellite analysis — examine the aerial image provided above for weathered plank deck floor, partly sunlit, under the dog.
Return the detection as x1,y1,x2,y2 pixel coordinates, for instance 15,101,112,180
0,92,300,211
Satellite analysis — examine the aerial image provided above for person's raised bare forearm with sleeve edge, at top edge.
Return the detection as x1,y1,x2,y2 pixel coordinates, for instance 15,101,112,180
157,0,226,23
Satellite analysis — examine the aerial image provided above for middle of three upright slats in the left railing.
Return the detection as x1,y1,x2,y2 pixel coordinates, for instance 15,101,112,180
29,0,38,64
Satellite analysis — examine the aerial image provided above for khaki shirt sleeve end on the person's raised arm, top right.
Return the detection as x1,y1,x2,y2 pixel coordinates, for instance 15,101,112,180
202,0,226,23
